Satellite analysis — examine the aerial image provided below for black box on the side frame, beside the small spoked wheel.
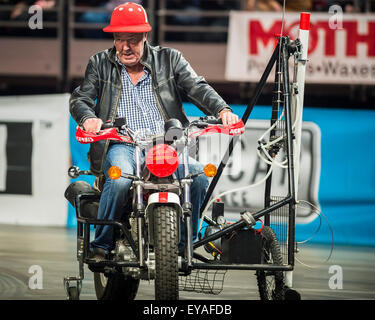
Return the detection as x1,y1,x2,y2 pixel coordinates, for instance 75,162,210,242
221,229,263,264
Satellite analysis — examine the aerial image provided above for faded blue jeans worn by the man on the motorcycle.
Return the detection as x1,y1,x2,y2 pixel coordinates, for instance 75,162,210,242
91,144,208,252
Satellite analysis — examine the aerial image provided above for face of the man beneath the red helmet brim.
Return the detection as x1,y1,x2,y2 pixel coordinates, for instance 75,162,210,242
114,33,146,67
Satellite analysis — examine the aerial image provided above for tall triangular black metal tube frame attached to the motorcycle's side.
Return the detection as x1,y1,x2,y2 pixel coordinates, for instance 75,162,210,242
194,37,300,271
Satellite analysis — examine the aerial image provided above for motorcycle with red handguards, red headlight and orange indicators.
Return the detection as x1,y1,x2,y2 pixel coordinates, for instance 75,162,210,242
64,117,245,300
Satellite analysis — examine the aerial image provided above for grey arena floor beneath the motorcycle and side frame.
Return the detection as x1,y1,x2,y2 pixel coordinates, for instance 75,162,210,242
0,225,375,300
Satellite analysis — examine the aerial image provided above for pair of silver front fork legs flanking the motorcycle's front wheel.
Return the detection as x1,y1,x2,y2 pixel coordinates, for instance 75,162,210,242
134,145,193,269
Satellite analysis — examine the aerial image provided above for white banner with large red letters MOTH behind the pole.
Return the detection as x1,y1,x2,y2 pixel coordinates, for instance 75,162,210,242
225,11,375,84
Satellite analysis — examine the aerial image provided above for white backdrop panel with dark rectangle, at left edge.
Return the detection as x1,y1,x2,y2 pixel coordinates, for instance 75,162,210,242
0,94,70,226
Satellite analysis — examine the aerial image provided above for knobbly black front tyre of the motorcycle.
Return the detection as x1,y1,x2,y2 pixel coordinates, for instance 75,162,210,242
153,206,179,300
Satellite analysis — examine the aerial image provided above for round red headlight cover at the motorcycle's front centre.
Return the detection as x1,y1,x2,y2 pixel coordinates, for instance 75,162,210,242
146,144,179,178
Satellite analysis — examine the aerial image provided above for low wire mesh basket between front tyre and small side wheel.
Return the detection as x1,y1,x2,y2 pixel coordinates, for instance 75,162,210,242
179,269,227,295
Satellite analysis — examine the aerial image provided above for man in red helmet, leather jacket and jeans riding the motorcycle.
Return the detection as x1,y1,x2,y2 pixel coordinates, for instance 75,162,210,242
70,2,238,260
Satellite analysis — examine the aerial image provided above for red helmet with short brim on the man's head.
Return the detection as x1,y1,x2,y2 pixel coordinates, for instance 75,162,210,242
103,2,152,32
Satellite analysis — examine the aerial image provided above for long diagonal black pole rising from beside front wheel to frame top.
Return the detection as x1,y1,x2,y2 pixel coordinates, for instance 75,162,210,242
200,44,279,225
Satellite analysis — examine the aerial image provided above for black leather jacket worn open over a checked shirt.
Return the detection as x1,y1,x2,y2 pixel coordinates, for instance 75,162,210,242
69,42,230,175
